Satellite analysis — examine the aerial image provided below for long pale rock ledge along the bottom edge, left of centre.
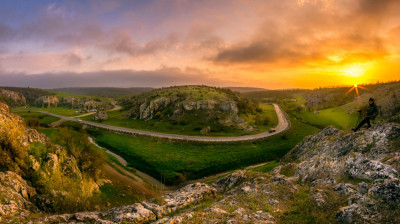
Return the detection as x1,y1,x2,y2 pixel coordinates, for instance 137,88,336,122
34,183,217,223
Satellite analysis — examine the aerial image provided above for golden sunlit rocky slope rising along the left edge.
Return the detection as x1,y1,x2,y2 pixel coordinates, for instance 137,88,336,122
0,103,101,223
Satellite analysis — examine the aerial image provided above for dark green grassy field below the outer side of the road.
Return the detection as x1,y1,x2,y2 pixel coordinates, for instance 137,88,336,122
88,117,318,184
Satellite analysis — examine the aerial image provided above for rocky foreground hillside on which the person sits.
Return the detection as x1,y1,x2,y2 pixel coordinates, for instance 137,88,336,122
28,117,400,224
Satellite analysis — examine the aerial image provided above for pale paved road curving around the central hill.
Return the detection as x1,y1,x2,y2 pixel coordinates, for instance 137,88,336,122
16,104,290,142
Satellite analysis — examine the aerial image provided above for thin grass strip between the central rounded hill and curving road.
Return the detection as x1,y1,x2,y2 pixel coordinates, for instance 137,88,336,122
81,104,278,136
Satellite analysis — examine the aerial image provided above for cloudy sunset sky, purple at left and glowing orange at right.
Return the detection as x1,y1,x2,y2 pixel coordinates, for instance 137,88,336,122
0,0,400,89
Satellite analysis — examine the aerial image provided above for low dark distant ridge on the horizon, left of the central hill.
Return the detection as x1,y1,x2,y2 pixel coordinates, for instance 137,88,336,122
54,87,153,97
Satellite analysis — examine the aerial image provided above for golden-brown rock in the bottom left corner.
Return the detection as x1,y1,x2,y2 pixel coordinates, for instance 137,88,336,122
0,171,39,222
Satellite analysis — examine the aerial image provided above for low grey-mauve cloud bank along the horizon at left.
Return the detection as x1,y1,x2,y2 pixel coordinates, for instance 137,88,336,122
0,68,240,88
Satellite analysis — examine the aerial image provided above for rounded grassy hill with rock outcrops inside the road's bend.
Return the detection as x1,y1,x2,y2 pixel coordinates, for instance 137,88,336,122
121,86,262,133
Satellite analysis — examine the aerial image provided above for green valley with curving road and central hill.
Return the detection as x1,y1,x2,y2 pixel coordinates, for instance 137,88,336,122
0,83,396,222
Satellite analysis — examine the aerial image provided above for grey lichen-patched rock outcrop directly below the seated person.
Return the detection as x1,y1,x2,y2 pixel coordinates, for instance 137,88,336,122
285,123,400,181
